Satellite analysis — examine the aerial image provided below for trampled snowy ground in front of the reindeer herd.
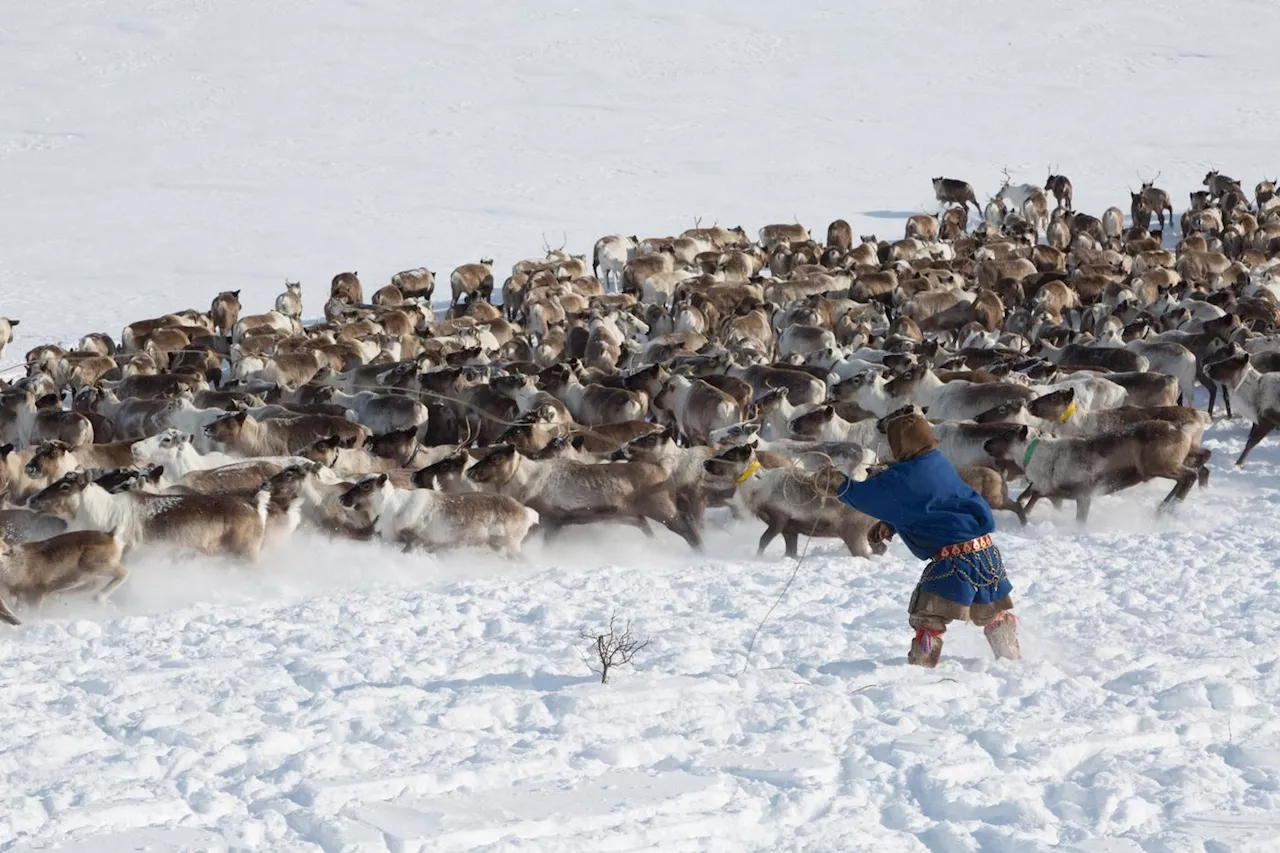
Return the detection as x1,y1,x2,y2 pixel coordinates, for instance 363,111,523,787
0,425,1280,853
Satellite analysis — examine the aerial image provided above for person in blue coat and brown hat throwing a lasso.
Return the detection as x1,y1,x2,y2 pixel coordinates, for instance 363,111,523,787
814,412,1021,667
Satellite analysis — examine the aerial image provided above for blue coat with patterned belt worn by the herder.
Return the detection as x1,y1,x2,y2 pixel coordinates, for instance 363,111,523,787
836,450,1012,605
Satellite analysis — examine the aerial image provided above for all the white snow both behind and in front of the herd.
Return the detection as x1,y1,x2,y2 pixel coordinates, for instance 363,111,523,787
0,0,1280,853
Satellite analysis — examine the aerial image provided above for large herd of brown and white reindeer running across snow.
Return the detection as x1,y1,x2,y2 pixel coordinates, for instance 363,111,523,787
0,163,1280,624
